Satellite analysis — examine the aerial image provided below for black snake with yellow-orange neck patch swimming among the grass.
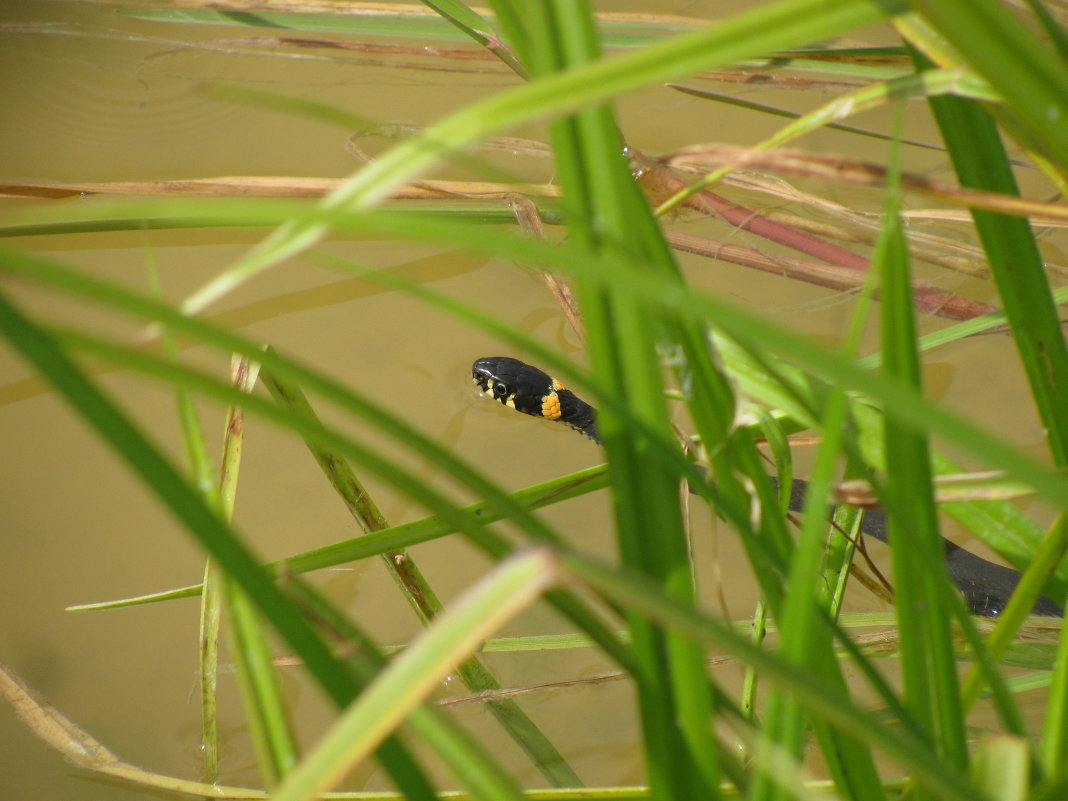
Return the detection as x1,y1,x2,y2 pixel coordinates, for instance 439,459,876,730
471,356,1064,617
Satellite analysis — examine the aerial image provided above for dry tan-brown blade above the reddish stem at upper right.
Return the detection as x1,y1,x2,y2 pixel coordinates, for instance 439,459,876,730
662,143,1068,222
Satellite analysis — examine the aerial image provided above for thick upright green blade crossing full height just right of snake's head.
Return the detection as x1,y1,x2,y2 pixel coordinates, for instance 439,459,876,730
527,0,720,798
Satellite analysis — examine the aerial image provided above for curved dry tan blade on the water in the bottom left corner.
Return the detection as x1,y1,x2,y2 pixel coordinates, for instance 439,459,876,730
0,662,267,799
